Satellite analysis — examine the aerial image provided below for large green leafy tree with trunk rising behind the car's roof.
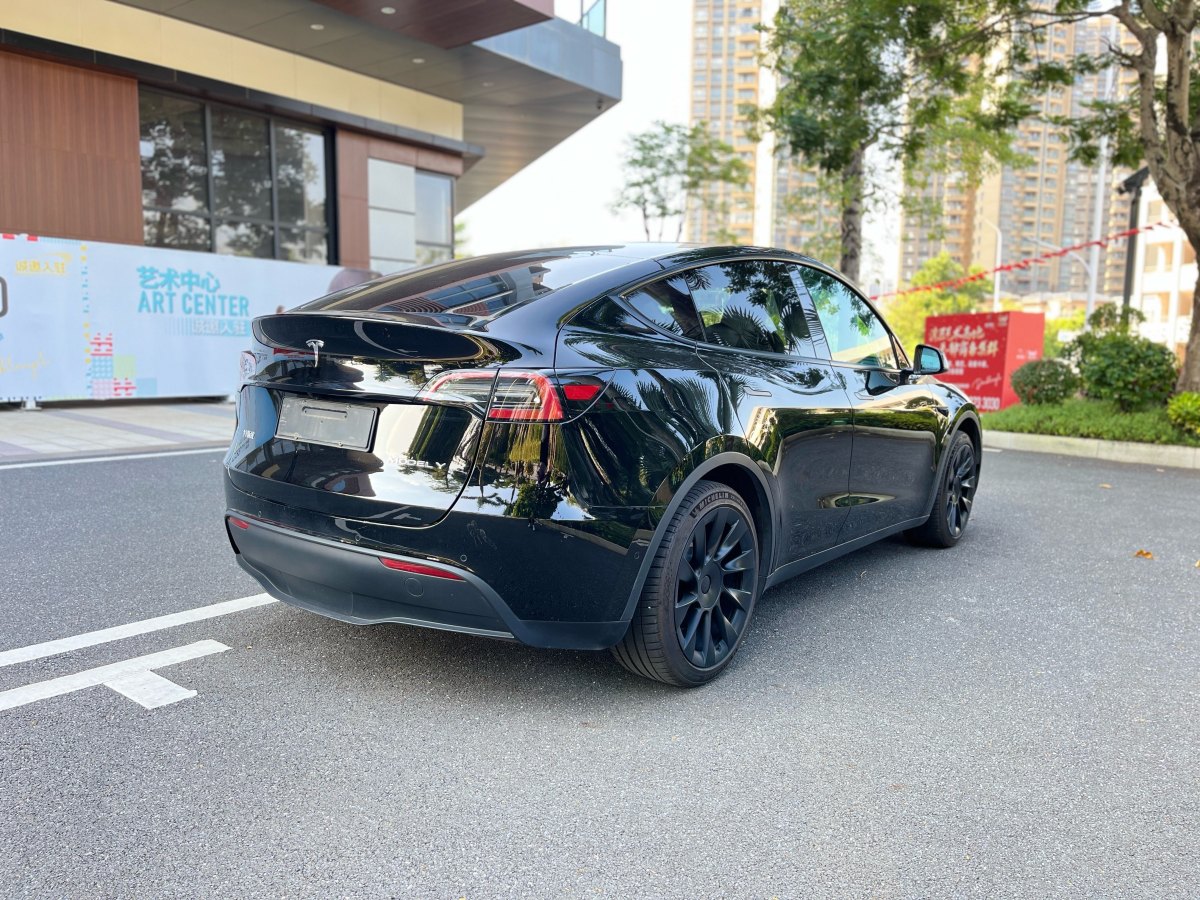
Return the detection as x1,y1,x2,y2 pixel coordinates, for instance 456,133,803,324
751,0,1030,280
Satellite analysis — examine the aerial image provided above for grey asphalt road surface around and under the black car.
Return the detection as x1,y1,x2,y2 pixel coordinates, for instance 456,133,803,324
0,452,1200,898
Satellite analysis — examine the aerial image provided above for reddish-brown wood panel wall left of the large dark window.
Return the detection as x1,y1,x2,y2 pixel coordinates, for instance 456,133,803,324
0,50,143,244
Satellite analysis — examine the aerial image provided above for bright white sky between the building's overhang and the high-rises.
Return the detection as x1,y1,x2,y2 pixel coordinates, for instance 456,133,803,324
457,0,899,287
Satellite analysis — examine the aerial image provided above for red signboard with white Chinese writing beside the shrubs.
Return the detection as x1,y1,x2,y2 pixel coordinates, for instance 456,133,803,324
925,312,1045,412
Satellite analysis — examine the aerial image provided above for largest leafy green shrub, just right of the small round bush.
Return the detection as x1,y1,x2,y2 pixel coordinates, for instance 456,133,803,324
1073,331,1176,413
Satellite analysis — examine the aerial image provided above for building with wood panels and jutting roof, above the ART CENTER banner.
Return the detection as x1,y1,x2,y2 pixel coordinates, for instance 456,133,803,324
0,0,620,272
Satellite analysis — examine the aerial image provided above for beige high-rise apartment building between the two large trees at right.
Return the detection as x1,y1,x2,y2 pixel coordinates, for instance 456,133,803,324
899,20,1128,298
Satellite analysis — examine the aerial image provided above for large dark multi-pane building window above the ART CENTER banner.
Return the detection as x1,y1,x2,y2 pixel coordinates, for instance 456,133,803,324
138,90,330,263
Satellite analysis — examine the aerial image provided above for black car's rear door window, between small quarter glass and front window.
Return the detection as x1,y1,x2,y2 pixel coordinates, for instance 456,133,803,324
684,259,814,356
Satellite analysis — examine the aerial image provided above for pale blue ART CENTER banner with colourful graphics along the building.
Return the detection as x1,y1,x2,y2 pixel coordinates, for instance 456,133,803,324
0,234,365,402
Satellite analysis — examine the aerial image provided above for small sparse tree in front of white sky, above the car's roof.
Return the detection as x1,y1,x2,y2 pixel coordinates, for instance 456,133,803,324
613,121,750,240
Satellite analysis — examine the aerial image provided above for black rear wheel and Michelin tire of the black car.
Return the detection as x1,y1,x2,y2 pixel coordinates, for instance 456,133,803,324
612,481,762,688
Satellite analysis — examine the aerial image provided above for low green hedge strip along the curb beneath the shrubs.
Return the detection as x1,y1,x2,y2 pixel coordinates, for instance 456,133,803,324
982,400,1200,446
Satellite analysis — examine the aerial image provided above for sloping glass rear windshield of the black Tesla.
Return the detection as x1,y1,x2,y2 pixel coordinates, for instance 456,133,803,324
296,248,629,320
